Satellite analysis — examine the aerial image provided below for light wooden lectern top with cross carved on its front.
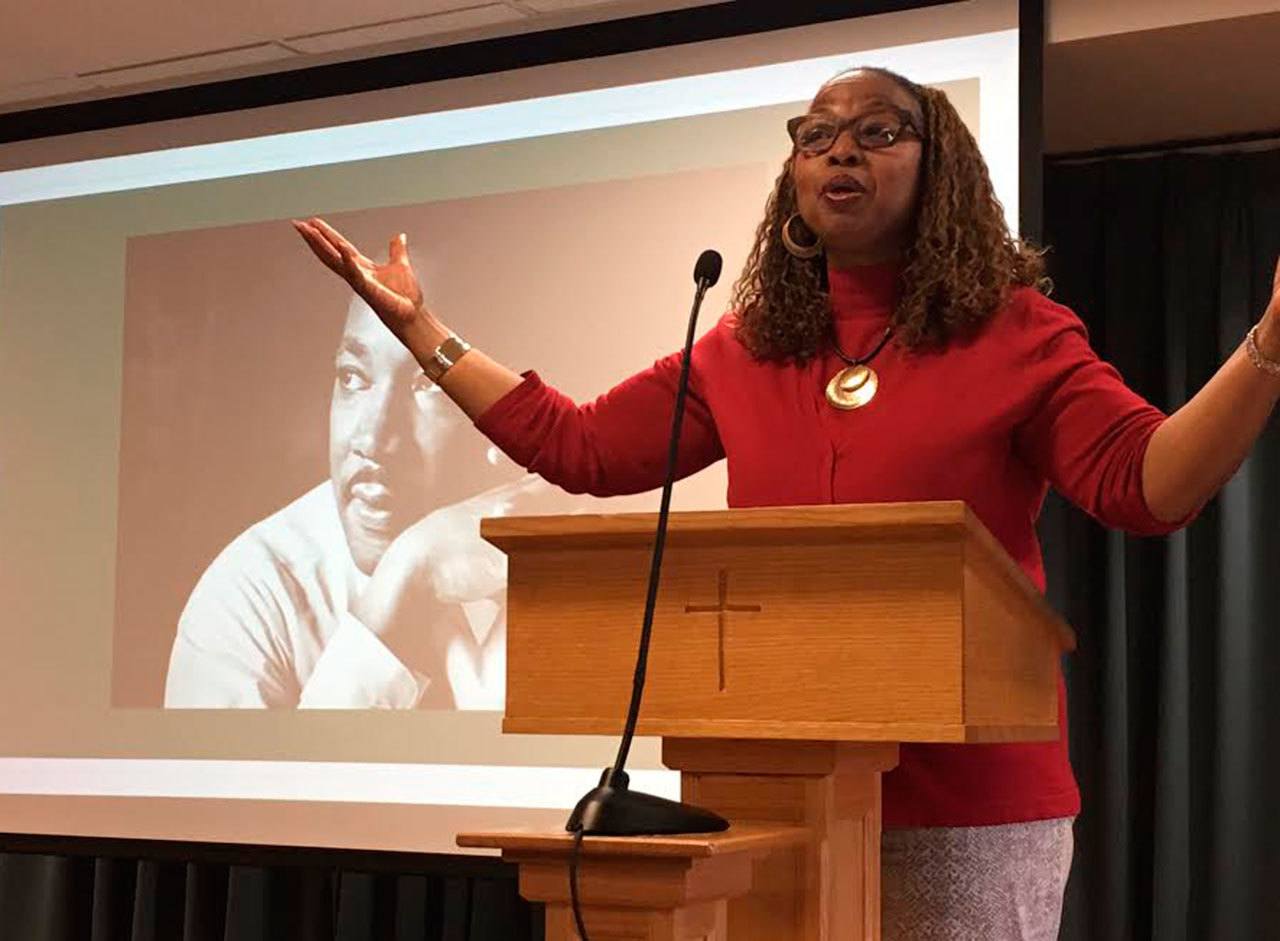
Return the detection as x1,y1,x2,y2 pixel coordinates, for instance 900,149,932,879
494,503,1071,743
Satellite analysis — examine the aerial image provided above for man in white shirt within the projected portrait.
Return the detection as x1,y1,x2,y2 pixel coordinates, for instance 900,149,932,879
158,290,549,709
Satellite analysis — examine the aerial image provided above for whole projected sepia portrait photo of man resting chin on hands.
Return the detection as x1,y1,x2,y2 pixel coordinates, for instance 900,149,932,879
113,165,772,711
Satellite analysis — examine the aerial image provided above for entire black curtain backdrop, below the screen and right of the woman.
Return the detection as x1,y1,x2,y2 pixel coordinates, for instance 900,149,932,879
0,145,1280,941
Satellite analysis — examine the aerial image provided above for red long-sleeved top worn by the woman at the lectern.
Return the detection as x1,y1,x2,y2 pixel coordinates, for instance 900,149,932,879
476,265,1187,827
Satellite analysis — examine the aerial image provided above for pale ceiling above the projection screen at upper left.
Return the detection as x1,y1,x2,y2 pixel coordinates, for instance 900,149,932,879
0,0,707,113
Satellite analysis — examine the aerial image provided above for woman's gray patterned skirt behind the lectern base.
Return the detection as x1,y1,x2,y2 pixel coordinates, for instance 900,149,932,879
881,817,1075,941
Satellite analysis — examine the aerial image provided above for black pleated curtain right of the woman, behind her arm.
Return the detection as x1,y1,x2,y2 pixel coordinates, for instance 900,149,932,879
1042,150,1280,941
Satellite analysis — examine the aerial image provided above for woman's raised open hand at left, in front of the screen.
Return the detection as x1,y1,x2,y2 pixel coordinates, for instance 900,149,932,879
292,216,422,343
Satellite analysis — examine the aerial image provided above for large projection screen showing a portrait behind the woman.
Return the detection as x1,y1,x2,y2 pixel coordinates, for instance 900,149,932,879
0,0,1019,851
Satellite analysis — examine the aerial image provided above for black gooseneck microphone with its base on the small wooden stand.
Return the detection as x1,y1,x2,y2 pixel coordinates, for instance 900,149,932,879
564,248,728,839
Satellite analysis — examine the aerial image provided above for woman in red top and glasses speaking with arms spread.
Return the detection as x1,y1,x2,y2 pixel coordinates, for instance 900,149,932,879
294,69,1280,941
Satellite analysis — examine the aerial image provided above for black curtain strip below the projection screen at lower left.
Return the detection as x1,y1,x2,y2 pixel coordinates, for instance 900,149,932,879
0,841,543,941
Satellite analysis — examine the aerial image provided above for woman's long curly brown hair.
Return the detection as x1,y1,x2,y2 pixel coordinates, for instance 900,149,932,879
733,68,1047,361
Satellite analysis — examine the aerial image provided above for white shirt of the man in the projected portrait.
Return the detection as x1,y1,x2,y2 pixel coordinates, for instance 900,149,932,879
165,479,509,709
